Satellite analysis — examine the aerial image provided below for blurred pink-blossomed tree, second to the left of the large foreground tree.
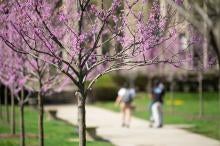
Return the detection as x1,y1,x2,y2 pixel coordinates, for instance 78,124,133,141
2,47,33,146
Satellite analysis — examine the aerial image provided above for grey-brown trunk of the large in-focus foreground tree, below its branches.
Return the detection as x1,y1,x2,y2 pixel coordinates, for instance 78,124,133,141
76,93,86,146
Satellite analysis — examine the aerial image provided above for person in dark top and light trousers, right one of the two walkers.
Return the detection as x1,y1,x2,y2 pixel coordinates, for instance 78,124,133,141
150,81,165,128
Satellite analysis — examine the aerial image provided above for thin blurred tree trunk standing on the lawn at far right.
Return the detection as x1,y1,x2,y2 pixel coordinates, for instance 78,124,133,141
198,72,204,118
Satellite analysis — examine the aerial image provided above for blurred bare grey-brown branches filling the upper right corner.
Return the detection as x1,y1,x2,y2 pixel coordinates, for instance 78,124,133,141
166,0,220,62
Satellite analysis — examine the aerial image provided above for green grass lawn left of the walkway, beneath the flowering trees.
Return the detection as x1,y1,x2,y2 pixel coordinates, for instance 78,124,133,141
0,108,112,146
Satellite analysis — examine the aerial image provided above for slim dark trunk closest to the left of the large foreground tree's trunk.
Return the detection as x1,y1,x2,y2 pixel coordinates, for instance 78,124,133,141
38,93,44,146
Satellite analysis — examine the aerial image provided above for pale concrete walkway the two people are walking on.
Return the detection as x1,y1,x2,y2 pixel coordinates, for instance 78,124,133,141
46,105,220,146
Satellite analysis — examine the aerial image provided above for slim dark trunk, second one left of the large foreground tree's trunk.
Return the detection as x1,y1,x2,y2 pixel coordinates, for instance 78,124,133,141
20,89,25,146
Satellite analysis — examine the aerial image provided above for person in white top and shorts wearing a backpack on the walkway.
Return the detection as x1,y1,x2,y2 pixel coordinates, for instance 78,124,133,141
115,87,136,128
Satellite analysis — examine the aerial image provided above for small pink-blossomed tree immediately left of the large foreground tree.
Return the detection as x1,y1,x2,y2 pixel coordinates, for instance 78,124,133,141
25,54,63,146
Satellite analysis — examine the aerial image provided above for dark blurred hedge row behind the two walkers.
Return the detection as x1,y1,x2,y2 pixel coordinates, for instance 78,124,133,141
92,73,218,100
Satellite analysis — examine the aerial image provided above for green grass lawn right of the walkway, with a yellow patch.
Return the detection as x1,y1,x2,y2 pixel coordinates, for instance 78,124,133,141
96,93,220,140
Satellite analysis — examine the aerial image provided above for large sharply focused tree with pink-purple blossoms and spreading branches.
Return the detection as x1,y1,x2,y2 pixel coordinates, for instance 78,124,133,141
0,0,186,146
